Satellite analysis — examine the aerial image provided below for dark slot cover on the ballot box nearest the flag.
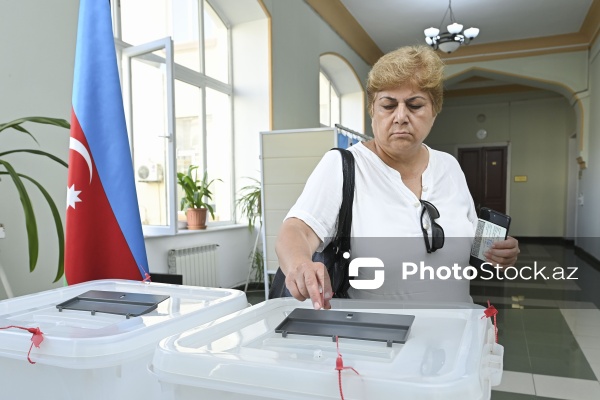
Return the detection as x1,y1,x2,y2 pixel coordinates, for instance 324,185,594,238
56,290,169,318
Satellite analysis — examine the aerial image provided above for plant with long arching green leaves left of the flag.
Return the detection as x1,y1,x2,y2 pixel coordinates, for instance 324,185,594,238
0,117,70,282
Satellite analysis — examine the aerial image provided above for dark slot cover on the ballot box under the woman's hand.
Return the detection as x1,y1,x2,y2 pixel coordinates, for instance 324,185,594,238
275,308,415,346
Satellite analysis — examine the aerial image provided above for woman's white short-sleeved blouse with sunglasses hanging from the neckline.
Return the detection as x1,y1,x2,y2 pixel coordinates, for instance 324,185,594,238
286,143,477,302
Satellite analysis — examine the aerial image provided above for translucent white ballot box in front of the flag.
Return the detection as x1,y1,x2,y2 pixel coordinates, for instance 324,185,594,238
0,280,248,400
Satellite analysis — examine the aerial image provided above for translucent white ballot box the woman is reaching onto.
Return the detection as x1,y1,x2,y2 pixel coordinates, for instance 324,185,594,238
150,298,503,400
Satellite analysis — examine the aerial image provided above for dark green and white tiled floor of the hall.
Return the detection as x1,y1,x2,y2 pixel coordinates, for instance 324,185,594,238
247,242,600,400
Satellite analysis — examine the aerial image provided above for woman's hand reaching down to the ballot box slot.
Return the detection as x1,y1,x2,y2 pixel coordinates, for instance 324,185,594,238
285,261,333,310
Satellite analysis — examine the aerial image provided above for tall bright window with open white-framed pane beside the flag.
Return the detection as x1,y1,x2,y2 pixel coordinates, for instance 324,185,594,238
113,0,234,235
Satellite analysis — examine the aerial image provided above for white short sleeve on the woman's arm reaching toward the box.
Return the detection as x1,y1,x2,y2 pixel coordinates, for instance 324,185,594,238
285,150,343,251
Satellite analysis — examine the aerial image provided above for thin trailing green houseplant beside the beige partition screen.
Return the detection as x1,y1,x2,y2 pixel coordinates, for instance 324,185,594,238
236,178,264,284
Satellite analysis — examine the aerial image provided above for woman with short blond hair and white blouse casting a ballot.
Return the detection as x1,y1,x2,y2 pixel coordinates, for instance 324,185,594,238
276,46,519,309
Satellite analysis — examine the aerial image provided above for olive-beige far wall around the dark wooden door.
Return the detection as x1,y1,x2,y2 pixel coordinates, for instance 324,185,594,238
426,96,575,237
